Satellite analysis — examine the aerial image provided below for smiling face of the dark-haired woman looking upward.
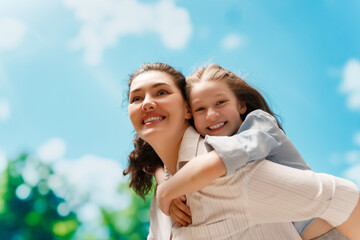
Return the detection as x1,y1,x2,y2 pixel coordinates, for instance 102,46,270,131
128,71,191,144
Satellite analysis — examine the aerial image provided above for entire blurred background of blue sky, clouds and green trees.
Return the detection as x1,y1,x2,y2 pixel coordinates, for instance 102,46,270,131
0,0,360,240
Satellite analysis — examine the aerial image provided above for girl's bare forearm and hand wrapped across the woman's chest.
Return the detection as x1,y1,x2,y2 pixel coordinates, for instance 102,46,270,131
156,151,226,215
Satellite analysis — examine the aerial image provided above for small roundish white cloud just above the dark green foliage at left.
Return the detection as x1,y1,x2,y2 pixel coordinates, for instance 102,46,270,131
37,138,66,163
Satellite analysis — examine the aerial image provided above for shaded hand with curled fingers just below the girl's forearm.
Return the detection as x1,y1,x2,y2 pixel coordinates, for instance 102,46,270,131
169,195,191,227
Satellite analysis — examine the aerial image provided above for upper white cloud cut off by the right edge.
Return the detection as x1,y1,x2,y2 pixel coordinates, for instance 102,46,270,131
340,59,360,110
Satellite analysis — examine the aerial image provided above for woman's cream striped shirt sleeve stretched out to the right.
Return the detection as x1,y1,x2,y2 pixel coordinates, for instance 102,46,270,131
246,160,359,226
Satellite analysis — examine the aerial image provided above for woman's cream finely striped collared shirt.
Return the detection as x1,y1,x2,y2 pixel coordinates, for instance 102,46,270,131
148,127,359,240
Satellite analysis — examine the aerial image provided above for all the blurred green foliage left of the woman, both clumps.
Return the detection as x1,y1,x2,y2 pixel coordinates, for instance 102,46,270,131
0,154,152,240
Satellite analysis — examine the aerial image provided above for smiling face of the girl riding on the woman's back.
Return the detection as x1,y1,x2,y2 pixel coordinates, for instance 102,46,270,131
189,81,246,136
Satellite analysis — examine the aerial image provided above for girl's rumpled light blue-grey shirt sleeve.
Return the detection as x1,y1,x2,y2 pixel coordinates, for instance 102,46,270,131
205,110,286,174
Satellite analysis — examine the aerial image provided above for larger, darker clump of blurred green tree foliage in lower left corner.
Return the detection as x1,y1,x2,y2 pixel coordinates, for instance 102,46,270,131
0,154,80,240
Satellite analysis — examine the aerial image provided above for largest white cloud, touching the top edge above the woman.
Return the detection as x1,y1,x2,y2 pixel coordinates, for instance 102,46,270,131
63,0,192,65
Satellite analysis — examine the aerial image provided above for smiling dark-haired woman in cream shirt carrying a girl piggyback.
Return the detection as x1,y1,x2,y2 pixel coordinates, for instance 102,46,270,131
126,63,360,239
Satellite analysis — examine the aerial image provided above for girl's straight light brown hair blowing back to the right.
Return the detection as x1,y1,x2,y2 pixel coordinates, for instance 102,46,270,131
186,64,282,129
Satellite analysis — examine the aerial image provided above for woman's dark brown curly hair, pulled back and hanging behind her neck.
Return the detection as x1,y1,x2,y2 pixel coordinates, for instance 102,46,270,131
123,63,186,198
